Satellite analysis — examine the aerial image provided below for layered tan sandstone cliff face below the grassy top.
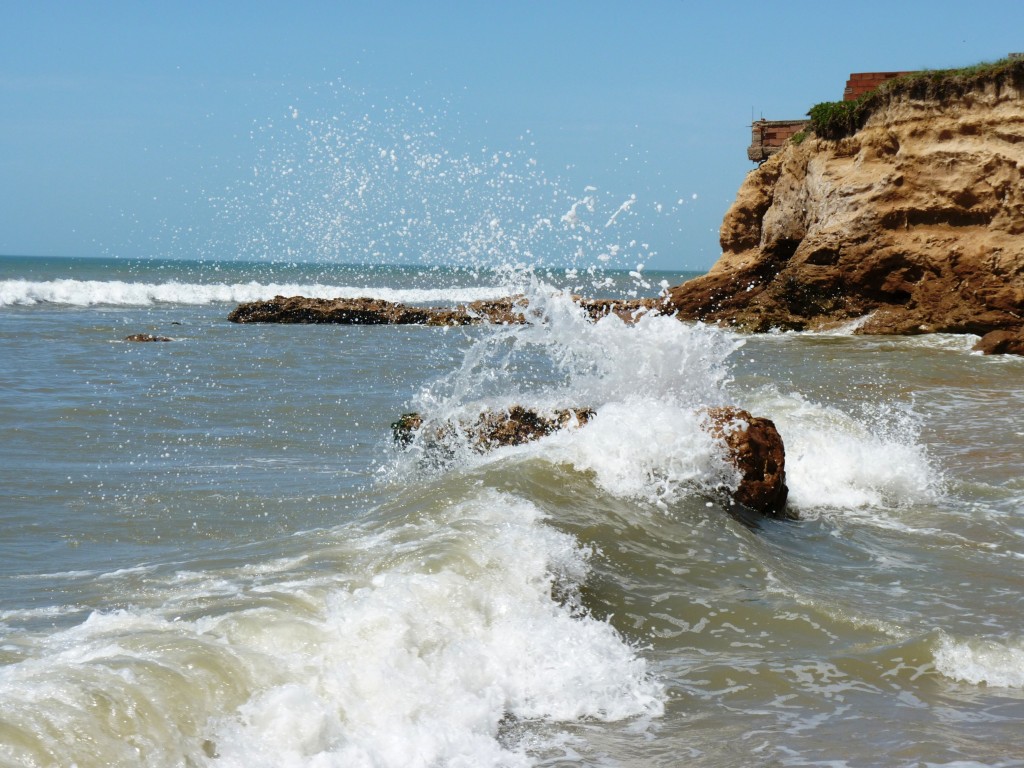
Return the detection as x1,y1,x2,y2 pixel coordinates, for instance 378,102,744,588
670,77,1024,342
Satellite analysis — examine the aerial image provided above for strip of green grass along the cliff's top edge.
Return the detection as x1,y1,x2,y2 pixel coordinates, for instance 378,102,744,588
807,58,1024,140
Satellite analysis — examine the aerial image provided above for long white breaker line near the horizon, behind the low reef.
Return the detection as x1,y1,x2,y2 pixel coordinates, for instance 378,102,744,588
0,280,508,306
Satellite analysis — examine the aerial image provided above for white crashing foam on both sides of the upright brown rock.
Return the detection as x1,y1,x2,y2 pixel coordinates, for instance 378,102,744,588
405,283,942,525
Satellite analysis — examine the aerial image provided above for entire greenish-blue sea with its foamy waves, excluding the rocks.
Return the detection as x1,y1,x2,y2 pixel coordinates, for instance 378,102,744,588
0,258,1024,768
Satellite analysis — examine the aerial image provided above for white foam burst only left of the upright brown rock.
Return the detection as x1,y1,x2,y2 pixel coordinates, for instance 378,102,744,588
407,285,741,505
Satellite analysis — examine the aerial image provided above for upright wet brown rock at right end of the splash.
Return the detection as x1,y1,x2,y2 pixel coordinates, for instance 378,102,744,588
706,407,796,518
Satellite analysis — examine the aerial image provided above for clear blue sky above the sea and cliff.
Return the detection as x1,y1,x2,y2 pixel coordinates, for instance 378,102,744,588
6,0,1024,269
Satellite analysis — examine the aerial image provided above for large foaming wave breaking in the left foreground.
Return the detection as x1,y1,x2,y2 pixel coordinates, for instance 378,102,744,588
0,482,664,766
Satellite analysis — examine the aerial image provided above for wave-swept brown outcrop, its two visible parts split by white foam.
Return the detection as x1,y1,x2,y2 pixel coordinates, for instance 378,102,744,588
391,406,796,518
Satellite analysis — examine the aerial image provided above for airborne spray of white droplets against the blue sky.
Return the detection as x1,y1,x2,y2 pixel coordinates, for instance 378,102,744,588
199,84,681,289
